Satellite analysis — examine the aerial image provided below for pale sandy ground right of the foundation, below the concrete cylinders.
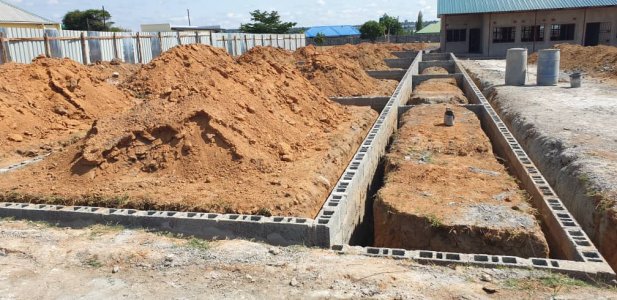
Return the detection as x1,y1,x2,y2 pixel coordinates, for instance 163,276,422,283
464,60,617,269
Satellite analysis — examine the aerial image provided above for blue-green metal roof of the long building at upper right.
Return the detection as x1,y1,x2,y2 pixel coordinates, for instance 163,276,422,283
437,0,617,16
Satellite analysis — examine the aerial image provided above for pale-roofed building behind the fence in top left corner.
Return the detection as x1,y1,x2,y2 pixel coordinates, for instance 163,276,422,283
0,0,60,30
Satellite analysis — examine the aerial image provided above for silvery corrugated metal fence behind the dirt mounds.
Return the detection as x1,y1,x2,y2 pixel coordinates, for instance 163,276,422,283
0,28,306,64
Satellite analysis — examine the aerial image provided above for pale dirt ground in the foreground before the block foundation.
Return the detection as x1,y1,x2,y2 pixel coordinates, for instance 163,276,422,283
0,219,617,299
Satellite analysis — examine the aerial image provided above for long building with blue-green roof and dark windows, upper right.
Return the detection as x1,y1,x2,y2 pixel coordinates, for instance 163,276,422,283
437,0,617,57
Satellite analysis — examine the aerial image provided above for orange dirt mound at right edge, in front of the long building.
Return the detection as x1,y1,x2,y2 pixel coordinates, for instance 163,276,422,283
529,44,617,79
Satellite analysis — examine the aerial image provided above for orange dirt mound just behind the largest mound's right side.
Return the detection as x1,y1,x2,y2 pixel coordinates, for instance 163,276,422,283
294,45,398,97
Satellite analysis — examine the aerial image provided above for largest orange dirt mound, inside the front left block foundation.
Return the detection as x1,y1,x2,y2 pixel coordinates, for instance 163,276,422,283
0,45,376,217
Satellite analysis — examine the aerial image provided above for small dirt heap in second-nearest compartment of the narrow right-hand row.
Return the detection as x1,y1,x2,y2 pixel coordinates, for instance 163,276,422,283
408,78,469,105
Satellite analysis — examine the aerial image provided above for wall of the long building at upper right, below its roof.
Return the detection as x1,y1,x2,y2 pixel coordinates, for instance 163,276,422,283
441,7,617,57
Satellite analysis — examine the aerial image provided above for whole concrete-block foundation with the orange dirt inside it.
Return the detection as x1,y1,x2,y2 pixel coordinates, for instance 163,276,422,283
0,45,615,280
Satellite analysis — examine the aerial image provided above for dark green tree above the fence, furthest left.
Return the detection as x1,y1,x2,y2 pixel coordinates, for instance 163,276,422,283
62,9,125,31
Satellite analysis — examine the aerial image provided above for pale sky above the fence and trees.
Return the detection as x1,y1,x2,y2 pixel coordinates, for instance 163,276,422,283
5,0,437,31
